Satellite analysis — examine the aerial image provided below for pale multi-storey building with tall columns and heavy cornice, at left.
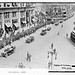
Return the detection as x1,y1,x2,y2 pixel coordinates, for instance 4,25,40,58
0,2,34,37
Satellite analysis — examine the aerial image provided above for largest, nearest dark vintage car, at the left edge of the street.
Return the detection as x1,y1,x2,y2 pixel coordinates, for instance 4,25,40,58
1,46,16,58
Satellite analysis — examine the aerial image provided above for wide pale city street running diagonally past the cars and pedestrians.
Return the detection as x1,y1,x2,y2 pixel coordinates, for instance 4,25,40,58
0,12,75,70
